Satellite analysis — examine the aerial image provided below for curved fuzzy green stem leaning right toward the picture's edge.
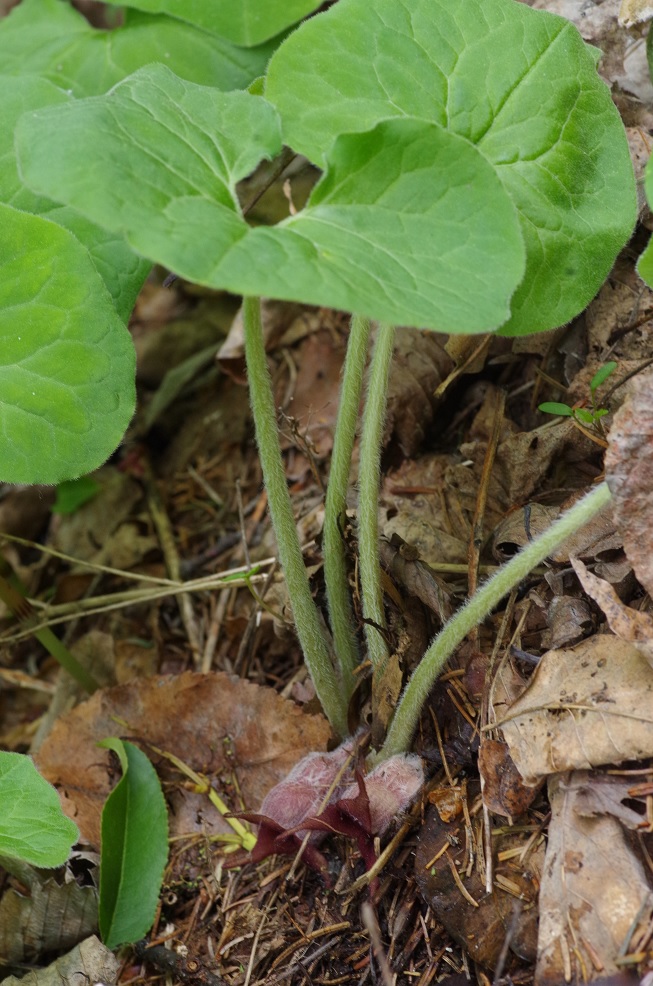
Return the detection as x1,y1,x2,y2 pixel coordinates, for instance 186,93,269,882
376,483,610,762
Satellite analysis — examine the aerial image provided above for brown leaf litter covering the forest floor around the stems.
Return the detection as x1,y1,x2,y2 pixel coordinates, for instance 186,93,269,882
5,0,653,986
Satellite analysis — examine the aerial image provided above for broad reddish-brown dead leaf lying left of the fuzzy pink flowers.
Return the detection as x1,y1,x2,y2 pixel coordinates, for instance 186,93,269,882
37,671,330,847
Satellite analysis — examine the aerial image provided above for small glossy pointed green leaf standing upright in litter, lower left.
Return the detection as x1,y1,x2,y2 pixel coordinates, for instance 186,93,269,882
98,737,168,948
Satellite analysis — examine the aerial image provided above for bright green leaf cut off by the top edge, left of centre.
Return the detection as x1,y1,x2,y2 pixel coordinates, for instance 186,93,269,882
102,0,320,47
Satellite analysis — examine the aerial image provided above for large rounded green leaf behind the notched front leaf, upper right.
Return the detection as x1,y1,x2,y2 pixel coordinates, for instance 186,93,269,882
265,0,636,334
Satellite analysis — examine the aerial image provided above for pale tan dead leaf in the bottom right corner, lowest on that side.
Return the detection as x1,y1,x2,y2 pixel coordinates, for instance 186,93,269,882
535,771,653,986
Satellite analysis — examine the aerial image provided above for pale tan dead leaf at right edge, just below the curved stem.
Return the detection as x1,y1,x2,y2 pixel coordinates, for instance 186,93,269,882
493,634,653,784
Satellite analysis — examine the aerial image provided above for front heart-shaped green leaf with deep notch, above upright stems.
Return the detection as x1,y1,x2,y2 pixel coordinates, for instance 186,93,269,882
17,66,524,332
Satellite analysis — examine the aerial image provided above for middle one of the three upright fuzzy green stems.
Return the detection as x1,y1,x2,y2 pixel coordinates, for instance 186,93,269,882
322,315,370,699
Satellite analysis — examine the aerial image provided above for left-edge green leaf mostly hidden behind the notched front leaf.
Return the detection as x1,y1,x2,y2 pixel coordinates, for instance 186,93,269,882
0,75,151,322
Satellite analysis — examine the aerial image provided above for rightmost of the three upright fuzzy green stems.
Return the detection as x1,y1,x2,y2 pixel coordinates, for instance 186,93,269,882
358,324,395,672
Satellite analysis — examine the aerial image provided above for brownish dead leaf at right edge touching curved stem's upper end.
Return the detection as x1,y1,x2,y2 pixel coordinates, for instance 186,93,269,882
605,371,653,594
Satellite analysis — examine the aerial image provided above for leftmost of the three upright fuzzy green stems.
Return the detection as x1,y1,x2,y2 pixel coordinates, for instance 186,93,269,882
243,298,347,736
